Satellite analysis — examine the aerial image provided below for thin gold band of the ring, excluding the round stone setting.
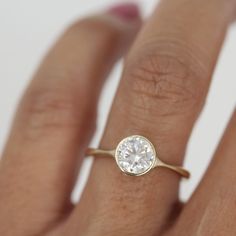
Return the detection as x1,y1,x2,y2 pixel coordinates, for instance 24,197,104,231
86,148,190,179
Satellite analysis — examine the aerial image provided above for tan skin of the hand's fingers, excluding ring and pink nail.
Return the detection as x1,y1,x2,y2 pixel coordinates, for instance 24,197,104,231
0,0,236,236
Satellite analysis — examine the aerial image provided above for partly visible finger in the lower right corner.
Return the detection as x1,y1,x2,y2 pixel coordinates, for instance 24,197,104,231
171,108,236,236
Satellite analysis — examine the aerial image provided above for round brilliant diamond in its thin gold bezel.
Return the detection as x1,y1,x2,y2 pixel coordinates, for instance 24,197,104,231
115,135,156,175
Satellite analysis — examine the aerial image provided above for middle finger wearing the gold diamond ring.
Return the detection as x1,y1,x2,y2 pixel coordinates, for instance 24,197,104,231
69,0,235,236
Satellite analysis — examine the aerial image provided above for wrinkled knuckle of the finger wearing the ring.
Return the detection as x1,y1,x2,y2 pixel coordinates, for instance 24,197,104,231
125,53,204,115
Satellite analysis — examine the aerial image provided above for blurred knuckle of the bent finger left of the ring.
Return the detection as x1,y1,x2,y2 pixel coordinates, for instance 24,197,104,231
23,84,78,137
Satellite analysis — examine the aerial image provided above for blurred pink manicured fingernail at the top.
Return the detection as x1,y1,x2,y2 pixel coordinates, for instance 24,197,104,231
108,3,140,21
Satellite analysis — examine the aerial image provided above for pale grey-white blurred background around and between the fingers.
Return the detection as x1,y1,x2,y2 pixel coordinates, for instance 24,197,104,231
0,0,236,199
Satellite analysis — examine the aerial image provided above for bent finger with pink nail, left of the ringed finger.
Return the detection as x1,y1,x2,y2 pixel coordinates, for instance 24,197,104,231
0,8,140,235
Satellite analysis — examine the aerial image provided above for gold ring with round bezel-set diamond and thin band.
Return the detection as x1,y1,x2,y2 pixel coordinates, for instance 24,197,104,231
86,135,190,178
